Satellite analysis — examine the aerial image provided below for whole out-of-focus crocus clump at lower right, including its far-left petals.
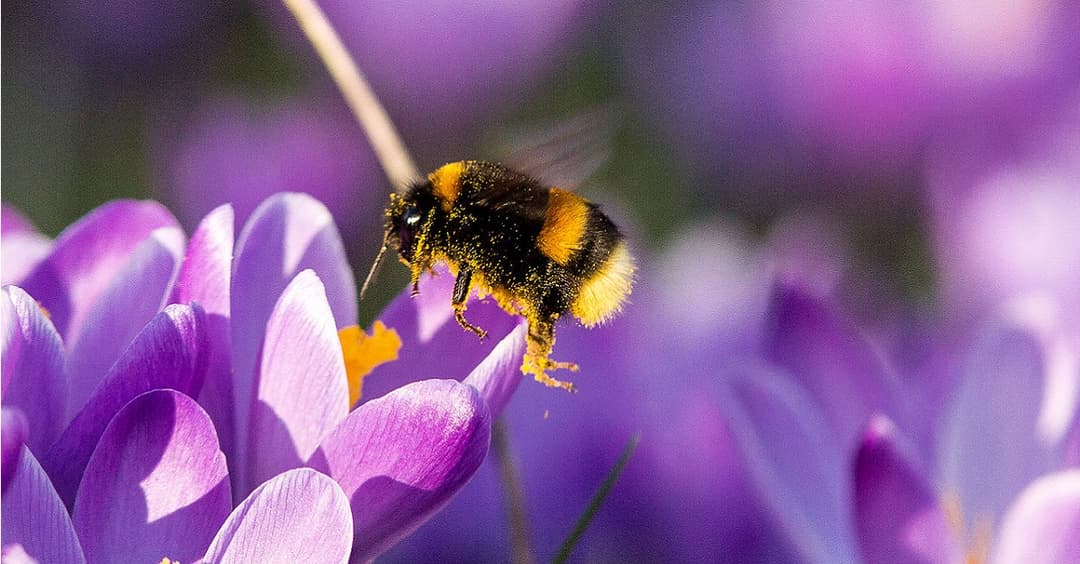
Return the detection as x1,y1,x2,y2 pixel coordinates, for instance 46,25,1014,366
695,258,1080,562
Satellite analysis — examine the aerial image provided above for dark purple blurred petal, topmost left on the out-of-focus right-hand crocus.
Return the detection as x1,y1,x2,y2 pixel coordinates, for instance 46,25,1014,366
765,285,899,448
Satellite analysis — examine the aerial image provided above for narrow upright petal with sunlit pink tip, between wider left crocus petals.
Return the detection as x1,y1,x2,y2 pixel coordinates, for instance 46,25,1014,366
171,204,235,468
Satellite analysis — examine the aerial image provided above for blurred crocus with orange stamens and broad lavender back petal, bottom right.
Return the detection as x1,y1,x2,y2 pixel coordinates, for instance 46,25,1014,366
854,300,1080,562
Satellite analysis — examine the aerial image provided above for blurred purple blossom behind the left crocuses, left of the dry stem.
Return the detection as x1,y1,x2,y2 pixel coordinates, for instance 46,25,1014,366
154,96,382,241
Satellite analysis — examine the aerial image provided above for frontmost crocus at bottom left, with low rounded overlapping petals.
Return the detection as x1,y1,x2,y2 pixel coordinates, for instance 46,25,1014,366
3,389,352,562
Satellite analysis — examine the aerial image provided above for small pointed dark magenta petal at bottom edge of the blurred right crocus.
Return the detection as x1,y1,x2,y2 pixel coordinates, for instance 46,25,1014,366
854,417,959,564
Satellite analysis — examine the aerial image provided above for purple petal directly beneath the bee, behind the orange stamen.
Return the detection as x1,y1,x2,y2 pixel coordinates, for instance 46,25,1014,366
362,266,518,401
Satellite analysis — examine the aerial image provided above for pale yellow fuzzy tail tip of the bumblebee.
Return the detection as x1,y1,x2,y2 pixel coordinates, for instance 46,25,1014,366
570,242,635,327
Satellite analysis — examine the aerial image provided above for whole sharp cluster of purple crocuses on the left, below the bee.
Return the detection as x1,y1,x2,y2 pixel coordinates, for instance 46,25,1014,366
0,193,524,562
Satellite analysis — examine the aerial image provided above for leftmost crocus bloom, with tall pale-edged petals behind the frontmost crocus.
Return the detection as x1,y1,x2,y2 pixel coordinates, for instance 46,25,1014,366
0,196,207,503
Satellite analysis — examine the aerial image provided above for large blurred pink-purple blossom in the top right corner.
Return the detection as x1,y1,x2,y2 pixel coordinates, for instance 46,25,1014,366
621,1,1080,191
